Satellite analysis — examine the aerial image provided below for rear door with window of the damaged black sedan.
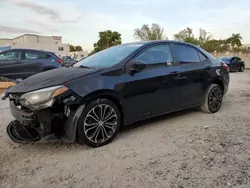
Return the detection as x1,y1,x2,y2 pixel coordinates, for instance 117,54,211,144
173,44,212,108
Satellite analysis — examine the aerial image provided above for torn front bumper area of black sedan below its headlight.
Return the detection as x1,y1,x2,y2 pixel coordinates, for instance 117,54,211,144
7,101,85,143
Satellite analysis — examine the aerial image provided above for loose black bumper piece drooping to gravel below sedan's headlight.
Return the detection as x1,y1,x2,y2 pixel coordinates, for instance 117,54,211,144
7,120,41,144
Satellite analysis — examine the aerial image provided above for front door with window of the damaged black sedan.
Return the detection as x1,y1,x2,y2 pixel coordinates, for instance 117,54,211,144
121,44,180,119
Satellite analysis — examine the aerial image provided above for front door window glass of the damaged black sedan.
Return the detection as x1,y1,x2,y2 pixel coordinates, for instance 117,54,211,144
135,45,173,67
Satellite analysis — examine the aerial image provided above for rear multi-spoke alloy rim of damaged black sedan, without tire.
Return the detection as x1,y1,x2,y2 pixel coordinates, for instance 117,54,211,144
208,87,223,112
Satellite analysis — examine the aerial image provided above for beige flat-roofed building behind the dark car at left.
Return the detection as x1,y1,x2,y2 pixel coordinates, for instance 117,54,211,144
0,34,69,56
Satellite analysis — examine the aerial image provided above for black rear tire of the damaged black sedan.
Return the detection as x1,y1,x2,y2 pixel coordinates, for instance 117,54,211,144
201,84,223,114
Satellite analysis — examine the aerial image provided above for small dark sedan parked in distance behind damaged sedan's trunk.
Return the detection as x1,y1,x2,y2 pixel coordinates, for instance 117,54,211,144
221,56,245,72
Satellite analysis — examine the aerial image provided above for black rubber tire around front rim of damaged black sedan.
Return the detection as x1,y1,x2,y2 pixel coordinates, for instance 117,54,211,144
77,99,121,147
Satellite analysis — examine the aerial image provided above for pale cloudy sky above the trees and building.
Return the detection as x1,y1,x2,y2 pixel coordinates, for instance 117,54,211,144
0,0,250,50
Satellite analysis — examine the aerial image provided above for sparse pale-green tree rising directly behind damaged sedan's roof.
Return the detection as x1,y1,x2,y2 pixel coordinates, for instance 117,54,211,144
134,23,168,41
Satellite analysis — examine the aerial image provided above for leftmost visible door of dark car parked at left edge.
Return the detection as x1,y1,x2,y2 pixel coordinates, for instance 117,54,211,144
0,50,23,79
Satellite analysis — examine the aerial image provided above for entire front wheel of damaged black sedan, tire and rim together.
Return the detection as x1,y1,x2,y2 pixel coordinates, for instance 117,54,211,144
77,99,121,147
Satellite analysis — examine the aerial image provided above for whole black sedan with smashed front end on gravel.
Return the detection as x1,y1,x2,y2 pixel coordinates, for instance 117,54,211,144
4,41,229,147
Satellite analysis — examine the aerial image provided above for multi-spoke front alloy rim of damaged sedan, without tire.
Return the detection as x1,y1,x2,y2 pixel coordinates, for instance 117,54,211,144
83,104,118,143
